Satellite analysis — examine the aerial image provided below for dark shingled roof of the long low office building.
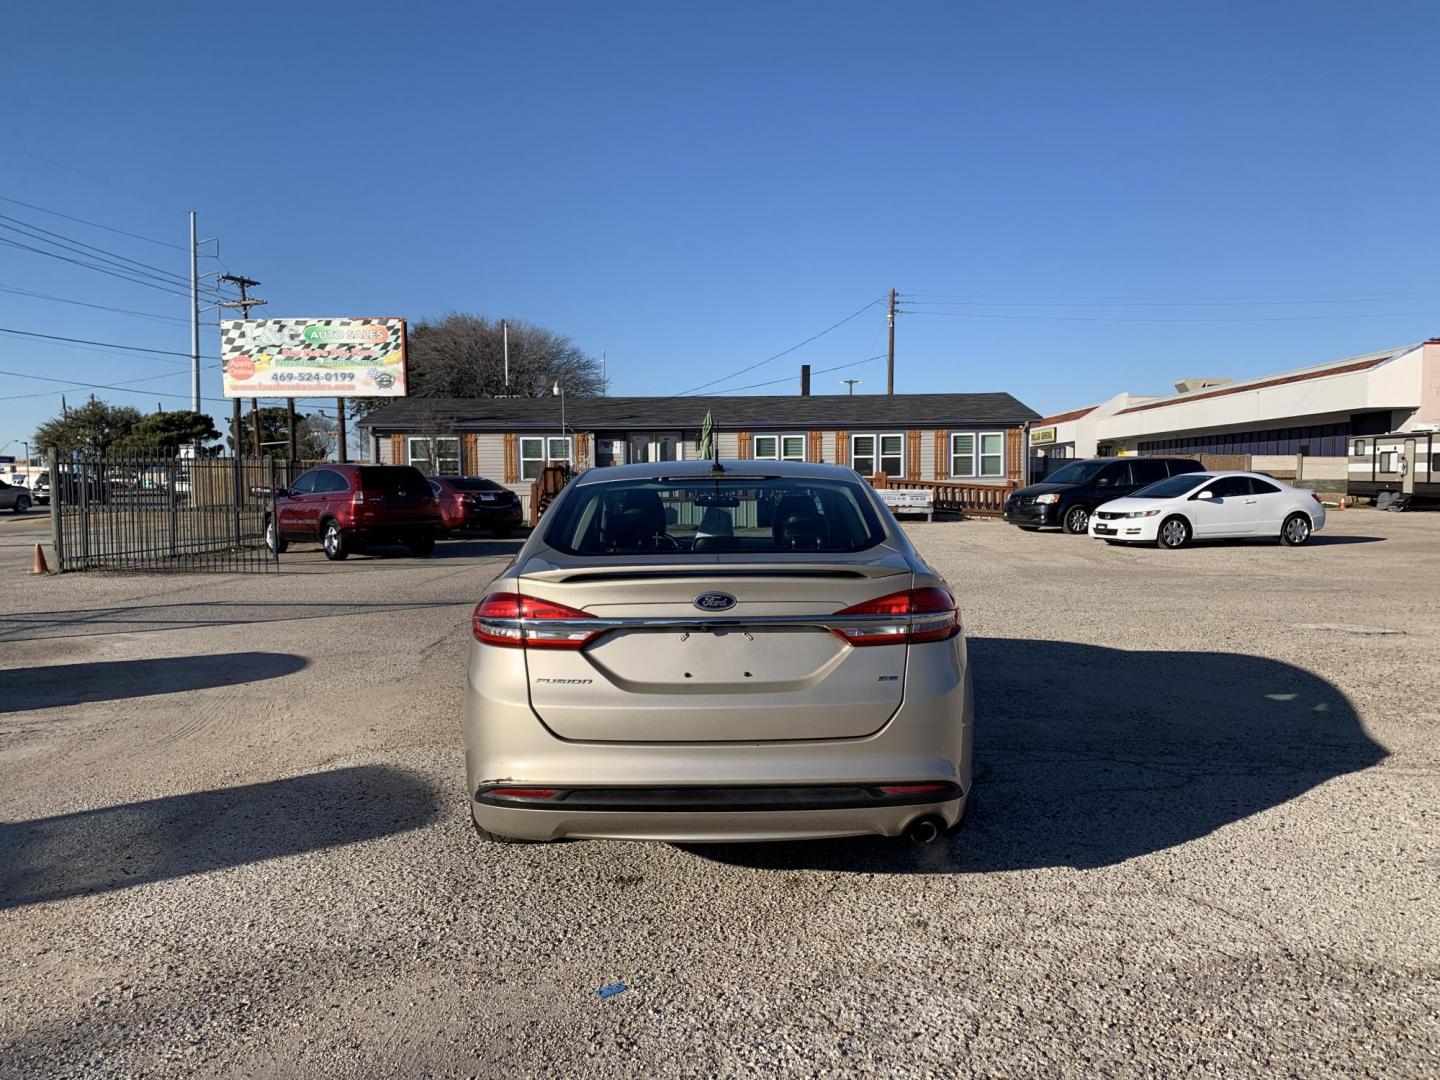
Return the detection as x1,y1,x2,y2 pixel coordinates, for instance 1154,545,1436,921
360,393,1040,432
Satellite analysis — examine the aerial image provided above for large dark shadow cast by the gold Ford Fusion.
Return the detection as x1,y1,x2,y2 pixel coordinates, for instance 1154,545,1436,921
685,638,1385,874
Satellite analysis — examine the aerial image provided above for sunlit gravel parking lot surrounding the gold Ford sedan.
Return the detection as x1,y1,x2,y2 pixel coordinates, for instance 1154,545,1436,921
0,510,1440,1077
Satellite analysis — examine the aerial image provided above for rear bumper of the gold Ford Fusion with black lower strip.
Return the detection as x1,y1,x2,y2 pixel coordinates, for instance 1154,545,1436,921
465,638,973,841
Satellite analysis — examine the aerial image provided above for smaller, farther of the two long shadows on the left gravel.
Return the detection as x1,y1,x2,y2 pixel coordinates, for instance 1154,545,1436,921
0,652,310,713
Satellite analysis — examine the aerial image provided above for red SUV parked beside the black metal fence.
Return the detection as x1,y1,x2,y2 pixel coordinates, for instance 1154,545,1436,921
265,465,441,559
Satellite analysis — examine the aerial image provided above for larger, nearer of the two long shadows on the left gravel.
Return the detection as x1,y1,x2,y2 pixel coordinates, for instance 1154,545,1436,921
0,765,439,910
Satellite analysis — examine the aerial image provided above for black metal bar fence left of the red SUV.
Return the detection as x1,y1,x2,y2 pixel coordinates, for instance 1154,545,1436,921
50,455,285,573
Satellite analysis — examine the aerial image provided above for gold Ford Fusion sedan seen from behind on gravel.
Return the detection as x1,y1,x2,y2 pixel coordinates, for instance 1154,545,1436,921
465,461,972,841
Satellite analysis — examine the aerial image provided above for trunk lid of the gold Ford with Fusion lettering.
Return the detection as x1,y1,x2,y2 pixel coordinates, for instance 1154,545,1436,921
518,552,912,743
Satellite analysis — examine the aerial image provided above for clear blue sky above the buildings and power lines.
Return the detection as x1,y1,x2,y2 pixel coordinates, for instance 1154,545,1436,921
0,0,1440,452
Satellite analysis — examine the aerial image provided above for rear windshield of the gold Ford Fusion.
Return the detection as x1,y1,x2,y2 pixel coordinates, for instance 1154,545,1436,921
546,477,884,556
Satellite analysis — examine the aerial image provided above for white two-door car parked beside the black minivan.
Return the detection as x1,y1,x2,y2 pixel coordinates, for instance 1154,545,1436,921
1090,472,1325,547
